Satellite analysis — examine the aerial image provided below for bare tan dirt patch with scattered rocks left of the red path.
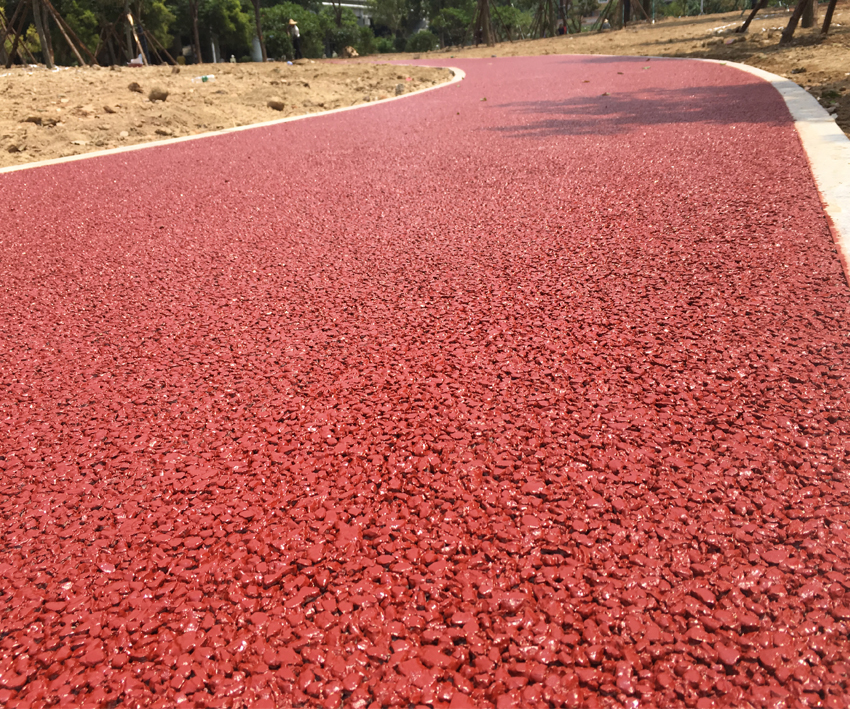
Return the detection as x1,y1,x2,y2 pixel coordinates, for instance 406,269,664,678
0,61,451,167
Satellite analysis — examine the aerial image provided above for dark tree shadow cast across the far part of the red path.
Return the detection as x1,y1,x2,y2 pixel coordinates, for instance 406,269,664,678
486,72,792,138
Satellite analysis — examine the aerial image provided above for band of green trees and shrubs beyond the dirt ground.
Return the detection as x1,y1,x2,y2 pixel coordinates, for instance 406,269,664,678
0,0,800,65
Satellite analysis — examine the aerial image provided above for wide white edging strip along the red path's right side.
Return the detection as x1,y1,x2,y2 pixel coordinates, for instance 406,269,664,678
703,59,850,282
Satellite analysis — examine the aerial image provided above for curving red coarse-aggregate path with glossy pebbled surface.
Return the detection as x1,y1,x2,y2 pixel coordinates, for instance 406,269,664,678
0,57,850,709
